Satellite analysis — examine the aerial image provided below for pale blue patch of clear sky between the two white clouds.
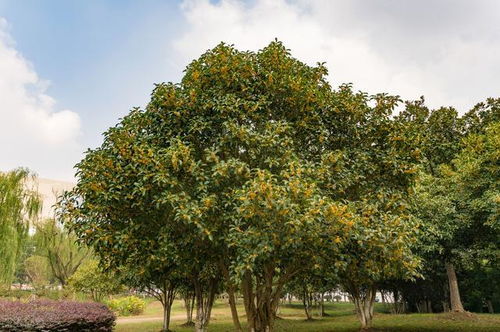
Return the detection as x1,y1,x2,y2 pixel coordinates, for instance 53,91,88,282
0,0,183,146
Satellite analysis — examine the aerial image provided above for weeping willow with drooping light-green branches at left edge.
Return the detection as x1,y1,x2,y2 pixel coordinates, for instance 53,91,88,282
0,169,41,287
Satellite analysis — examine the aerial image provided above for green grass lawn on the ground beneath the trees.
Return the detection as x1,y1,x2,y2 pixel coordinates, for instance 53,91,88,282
116,301,500,332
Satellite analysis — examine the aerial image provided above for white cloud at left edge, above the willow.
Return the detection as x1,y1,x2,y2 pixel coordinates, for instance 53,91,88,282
0,18,81,179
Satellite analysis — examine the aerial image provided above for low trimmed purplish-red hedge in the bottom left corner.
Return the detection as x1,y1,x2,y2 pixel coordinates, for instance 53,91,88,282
0,300,116,332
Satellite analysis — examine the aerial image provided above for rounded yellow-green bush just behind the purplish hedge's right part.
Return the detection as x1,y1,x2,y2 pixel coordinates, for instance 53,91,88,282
68,260,122,302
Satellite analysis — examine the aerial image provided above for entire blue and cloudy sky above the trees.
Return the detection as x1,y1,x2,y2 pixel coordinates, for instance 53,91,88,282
0,0,500,180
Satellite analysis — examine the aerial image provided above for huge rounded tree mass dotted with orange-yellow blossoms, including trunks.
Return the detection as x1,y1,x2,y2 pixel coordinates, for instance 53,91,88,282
60,42,497,331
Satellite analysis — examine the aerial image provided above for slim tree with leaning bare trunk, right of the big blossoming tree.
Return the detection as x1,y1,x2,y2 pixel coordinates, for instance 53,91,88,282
398,102,465,311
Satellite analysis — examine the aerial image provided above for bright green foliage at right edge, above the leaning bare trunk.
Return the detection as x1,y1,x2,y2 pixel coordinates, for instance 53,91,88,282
415,123,500,265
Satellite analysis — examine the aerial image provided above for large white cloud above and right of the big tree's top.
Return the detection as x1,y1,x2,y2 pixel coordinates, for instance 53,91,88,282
171,0,500,112
